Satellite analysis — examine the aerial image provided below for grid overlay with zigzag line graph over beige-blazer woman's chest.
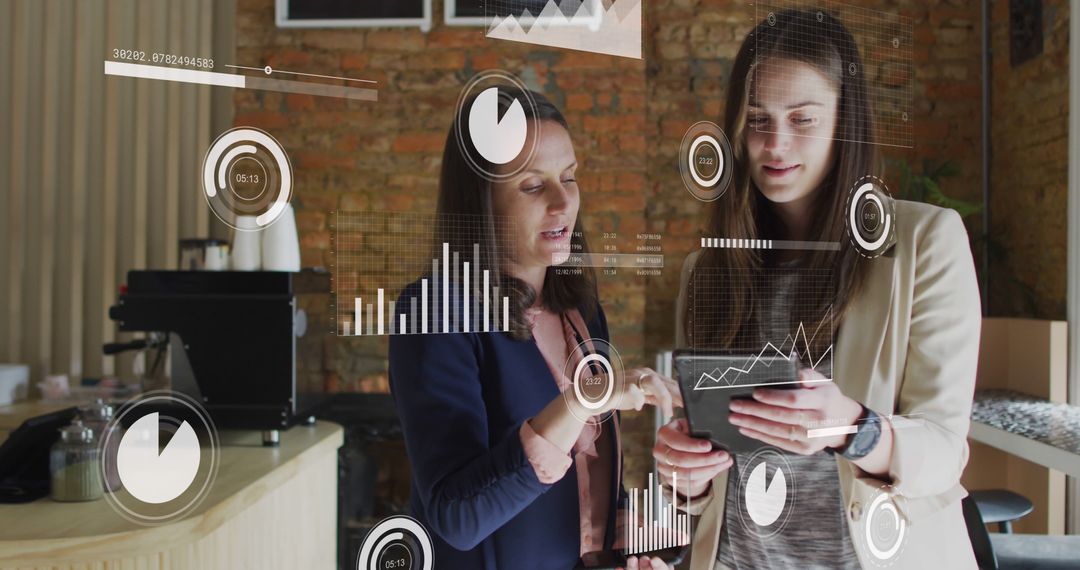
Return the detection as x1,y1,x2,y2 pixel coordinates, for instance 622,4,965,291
687,268,836,390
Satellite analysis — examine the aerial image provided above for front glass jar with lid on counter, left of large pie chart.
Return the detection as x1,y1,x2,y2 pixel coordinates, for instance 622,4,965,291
49,420,104,501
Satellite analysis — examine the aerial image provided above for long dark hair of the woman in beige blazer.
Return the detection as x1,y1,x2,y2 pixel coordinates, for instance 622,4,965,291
684,10,880,348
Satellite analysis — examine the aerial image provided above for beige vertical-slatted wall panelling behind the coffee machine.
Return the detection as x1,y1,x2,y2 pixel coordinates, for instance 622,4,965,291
0,0,234,382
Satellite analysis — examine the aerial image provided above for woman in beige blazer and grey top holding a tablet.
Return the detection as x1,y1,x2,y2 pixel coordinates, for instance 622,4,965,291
653,11,981,570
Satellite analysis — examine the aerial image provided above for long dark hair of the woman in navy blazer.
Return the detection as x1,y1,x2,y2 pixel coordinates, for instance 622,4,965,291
437,86,597,340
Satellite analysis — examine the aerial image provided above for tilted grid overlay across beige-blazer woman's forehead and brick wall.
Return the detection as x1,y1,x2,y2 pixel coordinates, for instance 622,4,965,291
754,0,915,148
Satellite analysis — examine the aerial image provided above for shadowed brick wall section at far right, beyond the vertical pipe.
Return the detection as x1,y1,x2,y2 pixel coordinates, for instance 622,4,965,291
990,0,1069,320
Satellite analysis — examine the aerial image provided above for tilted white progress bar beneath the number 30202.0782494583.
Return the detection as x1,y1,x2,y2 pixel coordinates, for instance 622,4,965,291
105,62,379,101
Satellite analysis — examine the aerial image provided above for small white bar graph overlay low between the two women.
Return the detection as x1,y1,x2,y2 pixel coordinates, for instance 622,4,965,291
624,471,690,556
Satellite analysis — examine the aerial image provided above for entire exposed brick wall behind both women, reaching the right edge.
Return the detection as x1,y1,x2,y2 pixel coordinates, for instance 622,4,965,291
234,0,1067,492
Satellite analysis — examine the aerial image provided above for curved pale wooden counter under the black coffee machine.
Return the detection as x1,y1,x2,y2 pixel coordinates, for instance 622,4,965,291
0,405,343,570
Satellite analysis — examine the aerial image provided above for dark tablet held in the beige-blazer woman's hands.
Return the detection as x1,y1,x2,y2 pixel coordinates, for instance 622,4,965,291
673,350,799,453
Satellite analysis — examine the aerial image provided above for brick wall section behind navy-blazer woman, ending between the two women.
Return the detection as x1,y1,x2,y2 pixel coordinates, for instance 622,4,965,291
234,0,652,485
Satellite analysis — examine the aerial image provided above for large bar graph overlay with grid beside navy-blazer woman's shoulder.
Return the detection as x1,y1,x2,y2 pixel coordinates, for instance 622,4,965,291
330,212,518,337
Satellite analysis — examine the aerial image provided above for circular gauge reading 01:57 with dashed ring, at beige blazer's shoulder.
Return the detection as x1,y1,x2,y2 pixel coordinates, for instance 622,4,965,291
845,176,896,258
